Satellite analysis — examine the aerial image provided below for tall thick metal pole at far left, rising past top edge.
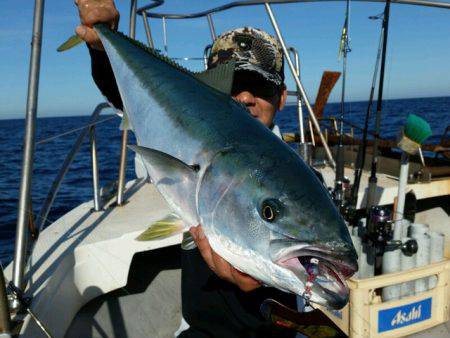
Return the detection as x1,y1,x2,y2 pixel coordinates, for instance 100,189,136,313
13,0,44,289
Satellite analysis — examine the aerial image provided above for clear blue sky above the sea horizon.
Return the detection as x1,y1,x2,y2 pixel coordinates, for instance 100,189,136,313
0,0,450,118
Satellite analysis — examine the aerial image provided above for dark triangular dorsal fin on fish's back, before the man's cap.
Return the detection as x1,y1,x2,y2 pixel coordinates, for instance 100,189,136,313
194,61,235,95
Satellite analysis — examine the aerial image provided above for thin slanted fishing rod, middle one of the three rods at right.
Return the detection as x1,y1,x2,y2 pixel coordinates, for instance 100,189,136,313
347,13,384,217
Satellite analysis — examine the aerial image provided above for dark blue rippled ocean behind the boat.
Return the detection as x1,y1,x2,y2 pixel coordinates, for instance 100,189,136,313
0,97,450,266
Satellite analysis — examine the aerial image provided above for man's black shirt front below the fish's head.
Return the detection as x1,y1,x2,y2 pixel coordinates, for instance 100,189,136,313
178,249,297,338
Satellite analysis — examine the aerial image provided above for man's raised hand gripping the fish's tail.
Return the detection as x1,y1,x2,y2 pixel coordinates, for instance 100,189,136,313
75,0,119,50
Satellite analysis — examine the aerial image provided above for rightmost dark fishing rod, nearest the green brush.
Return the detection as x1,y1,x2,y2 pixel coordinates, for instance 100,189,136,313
366,0,391,212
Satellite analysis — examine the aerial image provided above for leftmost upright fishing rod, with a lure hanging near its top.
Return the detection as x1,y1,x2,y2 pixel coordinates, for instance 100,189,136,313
333,0,351,208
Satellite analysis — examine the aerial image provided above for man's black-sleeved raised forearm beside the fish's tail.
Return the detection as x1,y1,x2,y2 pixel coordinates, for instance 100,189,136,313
88,46,123,110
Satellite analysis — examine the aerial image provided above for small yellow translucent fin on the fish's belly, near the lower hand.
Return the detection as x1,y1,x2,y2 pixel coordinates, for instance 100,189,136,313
136,214,186,241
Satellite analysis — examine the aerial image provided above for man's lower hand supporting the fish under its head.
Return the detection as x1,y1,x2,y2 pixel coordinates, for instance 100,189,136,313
189,225,261,292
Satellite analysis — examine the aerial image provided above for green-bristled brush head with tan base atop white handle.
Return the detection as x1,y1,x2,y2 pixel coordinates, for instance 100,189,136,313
398,114,431,155
